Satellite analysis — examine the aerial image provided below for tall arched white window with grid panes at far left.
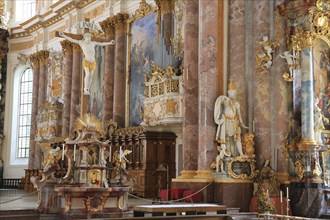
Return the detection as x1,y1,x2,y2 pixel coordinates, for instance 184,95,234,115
16,68,33,158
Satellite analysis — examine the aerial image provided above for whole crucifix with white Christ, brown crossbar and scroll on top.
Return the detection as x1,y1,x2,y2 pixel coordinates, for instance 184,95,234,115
56,20,115,95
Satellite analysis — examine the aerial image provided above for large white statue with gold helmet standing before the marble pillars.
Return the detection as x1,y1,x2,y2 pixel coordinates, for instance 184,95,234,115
214,82,248,157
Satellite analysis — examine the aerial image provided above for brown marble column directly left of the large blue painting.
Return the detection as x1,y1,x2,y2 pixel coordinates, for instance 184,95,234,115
113,13,128,127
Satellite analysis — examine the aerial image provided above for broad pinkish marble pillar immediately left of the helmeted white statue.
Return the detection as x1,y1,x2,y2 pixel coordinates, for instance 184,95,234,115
195,0,219,178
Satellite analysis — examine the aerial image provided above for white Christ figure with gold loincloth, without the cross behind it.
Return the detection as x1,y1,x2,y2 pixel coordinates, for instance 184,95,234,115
59,32,115,95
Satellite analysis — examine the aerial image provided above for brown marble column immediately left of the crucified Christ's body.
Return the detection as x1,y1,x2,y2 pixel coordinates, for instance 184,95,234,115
70,44,82,132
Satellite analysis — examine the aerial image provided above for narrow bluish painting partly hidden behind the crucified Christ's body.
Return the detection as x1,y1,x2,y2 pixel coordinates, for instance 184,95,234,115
87,46,104,118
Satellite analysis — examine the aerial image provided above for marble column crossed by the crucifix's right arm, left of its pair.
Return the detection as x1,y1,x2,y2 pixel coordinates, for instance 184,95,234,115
100,17,115,125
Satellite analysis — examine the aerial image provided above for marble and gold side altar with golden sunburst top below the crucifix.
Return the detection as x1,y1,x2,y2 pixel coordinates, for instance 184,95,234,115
31,114,133,217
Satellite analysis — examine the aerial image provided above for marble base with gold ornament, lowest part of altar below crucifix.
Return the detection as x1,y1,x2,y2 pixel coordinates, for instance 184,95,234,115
54,185,132,218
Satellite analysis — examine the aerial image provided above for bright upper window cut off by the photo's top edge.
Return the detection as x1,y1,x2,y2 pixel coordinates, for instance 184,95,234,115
15,0,36,21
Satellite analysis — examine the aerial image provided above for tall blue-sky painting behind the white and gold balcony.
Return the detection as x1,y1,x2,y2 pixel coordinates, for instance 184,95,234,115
129,13,157,126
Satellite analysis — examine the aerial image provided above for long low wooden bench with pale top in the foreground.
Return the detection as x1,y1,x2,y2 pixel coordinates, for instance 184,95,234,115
133,203,227,217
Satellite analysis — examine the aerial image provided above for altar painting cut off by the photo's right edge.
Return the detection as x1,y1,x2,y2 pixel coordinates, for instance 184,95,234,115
313,39,330,130
